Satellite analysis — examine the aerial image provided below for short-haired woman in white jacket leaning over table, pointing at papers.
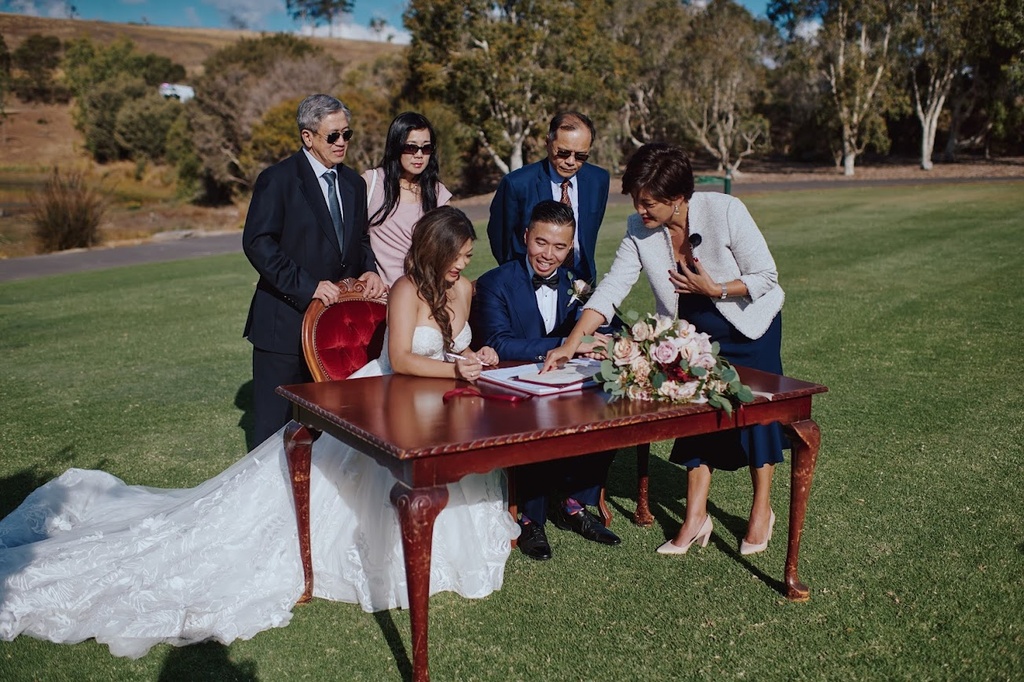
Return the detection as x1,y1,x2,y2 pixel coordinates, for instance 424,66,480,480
545,143,788,554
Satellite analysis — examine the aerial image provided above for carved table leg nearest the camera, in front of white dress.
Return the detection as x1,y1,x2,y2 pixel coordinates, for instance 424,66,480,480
391,482,447,682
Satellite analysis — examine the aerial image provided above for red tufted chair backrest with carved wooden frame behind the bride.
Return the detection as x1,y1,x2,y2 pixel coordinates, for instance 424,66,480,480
302,279,387,381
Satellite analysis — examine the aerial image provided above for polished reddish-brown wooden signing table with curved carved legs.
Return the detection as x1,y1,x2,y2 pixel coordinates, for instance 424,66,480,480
278,368,827,680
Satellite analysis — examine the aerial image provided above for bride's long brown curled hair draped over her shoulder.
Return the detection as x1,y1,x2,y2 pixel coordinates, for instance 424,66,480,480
406,206,476,351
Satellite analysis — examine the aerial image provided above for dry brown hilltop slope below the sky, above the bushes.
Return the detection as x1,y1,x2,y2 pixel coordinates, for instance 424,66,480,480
0,12,404,77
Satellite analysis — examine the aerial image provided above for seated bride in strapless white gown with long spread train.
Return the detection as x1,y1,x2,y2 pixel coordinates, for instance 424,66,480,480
0,207,518,657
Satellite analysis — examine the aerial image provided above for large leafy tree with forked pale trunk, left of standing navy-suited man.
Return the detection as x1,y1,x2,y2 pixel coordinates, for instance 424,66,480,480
404,0,610,173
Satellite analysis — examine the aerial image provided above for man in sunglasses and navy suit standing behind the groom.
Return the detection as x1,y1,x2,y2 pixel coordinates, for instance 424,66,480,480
487,112,609,283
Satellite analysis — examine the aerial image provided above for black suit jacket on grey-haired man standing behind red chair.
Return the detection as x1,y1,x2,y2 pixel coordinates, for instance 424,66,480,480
242,150,377,354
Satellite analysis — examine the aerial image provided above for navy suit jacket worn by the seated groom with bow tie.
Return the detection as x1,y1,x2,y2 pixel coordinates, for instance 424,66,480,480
470,257,581,360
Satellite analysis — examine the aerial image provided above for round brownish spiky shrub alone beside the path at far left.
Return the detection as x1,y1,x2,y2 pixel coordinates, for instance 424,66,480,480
29,168,106,253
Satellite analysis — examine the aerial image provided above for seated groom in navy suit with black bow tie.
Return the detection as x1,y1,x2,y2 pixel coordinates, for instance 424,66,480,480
470,200,621,560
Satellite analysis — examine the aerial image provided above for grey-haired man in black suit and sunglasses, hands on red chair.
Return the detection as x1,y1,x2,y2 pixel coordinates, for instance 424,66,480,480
242,94,385,442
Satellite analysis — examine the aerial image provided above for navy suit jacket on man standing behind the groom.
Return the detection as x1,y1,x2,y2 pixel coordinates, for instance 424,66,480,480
487,159,609,283
